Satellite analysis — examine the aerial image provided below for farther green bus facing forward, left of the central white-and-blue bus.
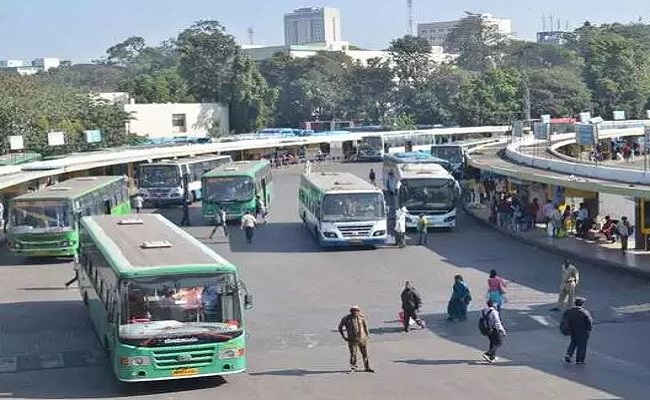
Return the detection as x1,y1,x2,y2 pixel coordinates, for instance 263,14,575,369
202,160,272,221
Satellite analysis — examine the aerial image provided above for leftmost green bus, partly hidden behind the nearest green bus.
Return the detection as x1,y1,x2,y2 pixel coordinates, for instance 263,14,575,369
7,176,131,257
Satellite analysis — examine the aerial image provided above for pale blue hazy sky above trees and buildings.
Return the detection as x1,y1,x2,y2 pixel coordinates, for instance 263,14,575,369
0,0,650,62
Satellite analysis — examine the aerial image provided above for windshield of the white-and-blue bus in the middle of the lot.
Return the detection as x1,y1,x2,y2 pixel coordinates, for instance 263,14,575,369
322,193,385,222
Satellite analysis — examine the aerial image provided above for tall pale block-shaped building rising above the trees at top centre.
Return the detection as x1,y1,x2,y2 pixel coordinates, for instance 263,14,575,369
284,7,343,46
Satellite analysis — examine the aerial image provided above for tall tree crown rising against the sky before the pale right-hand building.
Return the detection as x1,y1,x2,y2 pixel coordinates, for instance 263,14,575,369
443,14,508,72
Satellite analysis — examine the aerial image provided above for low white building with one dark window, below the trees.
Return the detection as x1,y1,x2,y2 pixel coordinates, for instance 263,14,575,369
124,102,230,138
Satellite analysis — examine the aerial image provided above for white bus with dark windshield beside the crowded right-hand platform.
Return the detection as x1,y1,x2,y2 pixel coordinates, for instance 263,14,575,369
395,163,461,230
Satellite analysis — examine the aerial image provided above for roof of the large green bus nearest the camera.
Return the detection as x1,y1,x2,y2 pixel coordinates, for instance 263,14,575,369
81,214,236,278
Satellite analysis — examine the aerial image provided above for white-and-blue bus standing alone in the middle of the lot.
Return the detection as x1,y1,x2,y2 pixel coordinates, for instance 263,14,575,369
298,172,387,246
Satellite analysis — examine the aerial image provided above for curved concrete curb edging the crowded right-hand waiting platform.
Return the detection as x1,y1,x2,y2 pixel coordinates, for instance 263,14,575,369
463,205,650,280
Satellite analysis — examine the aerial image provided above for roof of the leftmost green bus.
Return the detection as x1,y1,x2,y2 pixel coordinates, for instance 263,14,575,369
13,176,124,201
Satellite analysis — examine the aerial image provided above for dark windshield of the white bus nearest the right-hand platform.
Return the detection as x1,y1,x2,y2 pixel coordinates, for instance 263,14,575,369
400,179,458,212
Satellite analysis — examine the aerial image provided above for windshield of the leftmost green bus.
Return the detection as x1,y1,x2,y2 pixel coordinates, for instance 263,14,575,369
10,200,72,233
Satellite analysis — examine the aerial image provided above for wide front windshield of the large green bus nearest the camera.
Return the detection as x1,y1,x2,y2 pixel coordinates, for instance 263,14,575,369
119,273,241,345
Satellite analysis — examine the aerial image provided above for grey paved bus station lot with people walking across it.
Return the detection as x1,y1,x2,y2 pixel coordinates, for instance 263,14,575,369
0,164,650,400
